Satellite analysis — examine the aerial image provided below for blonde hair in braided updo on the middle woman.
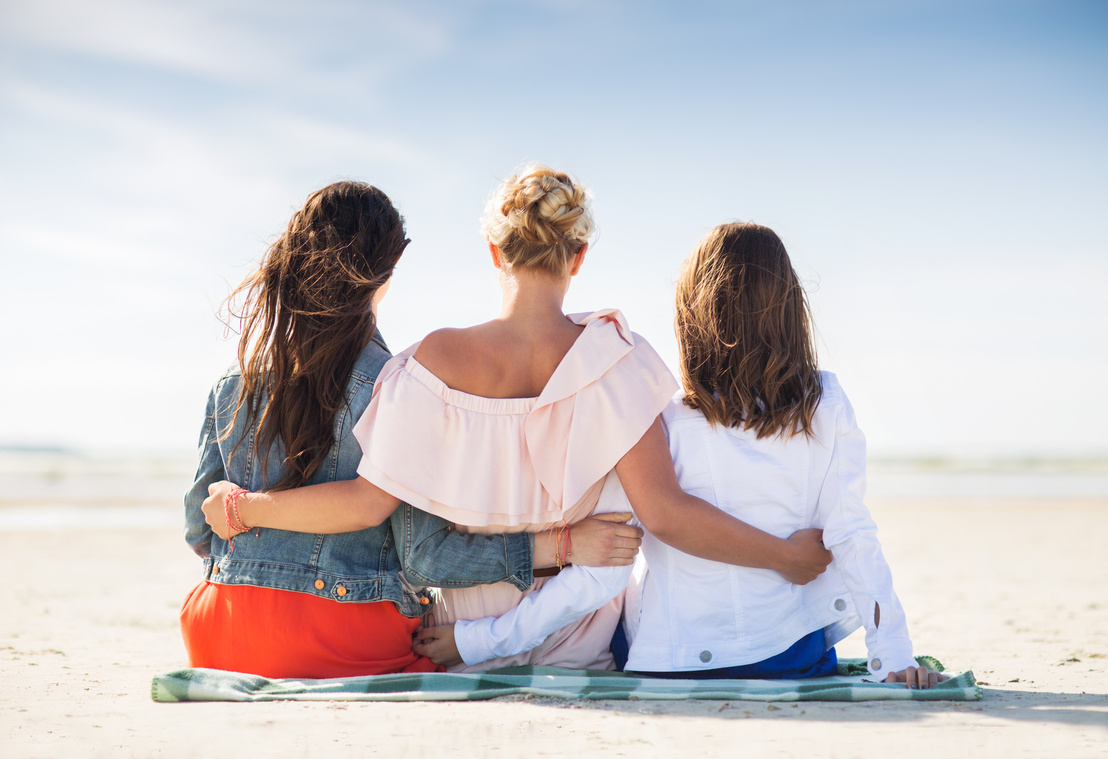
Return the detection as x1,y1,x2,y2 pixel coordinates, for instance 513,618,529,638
481,166,595,274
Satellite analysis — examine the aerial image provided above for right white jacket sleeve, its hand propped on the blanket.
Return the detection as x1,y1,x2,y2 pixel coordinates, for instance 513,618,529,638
817,387,915,679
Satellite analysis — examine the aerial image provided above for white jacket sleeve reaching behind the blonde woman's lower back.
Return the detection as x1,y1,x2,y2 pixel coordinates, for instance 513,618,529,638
454,471,632,665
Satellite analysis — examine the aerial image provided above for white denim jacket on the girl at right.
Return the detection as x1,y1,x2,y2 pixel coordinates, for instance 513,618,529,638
625,372,915,679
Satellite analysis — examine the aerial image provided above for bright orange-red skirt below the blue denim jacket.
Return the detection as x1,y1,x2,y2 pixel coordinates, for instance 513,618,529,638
181,582,442,678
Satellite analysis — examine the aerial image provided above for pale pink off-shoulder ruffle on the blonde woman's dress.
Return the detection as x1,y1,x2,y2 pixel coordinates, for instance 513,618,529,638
353,309,677,527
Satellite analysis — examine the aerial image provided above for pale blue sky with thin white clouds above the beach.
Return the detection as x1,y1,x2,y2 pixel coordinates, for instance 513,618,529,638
0,0,1108,458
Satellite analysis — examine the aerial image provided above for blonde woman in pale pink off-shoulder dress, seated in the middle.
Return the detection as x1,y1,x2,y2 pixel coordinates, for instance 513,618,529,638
205,166,829,670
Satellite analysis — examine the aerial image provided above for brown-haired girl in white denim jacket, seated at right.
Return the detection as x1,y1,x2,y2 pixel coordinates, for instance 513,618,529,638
627,224,946,688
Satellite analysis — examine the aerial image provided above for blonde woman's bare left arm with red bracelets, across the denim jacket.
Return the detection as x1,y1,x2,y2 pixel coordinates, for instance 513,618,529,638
203,478,400,540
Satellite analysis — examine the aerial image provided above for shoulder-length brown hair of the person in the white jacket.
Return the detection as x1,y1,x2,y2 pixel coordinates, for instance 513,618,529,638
676,224,823,439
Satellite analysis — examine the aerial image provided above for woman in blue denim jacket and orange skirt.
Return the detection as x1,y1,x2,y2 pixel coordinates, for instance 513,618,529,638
181,182,639,677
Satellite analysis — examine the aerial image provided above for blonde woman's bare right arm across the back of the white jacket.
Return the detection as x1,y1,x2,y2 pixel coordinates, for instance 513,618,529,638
616,420,831,585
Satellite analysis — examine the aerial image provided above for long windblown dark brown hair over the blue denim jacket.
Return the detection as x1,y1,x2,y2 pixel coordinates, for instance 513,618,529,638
225,182,409,490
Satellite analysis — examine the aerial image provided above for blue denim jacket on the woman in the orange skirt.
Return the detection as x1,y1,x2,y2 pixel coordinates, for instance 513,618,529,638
185,332,534,617
